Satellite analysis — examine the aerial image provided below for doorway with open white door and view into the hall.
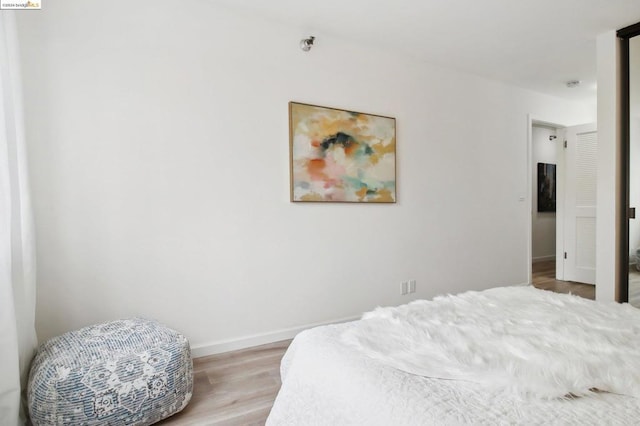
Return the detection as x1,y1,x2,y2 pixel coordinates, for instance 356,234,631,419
528,116,597,293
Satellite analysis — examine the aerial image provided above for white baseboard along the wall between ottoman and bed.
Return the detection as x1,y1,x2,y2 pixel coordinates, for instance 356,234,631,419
191,316,360,358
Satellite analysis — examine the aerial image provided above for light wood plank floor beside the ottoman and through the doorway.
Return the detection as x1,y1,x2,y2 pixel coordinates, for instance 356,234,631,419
158,261,595,426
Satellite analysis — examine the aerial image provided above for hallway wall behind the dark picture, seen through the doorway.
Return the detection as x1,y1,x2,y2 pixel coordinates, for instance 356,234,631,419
531,125,560,262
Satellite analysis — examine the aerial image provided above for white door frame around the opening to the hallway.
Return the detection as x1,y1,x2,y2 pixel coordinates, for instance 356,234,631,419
526,114,567,285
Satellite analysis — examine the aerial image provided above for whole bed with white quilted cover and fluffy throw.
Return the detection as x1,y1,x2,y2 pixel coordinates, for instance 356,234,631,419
267,287,640,426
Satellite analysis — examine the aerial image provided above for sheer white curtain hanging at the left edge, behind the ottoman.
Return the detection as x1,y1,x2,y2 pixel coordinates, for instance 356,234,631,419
0,11,36,426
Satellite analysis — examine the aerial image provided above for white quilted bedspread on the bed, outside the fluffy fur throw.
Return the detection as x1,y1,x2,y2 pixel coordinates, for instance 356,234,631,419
267,286,640,426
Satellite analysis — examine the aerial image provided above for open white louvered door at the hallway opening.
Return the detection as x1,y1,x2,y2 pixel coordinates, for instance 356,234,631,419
562,124,598,284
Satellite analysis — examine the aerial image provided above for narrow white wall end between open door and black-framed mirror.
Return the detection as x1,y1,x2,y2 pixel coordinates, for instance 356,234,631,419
596,31,621,301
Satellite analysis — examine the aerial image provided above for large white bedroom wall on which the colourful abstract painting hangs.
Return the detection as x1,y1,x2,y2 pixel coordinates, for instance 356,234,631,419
19,0,594,353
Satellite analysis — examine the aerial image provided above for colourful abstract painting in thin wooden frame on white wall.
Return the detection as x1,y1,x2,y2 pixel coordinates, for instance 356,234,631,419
289,102,396,203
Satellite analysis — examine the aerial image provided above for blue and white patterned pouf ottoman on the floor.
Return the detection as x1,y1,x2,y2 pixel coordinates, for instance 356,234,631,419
27,318,193,426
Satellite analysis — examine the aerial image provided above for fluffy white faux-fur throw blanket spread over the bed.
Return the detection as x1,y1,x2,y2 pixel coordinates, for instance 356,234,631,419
343,287,640,398
